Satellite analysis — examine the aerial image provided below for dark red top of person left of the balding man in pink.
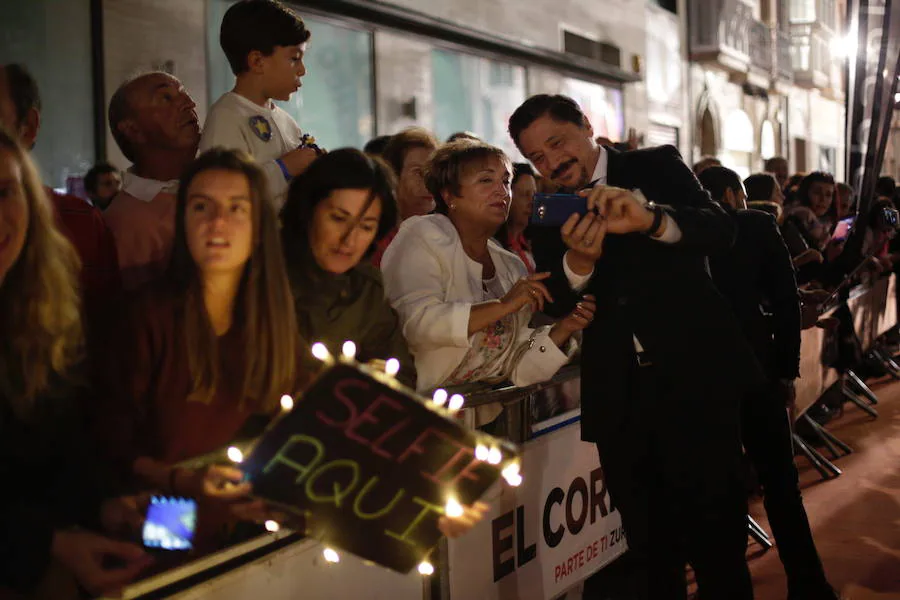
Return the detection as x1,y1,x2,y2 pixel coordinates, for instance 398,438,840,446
45,188,122,306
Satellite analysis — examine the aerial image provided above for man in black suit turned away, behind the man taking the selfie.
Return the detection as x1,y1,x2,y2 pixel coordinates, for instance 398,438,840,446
699,167,837,600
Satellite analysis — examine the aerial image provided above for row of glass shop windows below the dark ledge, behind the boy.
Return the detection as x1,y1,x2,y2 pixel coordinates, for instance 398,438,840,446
207,0,625,160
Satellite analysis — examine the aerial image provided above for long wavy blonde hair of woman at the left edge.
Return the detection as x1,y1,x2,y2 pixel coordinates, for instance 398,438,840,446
0,128,84,418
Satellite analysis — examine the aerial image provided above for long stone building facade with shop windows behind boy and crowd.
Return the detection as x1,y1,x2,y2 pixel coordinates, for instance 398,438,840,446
0,0,693,187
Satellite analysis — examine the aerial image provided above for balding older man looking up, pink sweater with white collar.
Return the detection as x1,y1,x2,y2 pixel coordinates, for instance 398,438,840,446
103,72,200,290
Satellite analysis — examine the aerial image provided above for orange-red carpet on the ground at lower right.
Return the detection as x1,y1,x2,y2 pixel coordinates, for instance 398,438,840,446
748,381,900,600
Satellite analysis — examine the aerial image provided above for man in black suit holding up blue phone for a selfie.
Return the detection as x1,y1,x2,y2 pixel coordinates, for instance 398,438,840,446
509,95,762,600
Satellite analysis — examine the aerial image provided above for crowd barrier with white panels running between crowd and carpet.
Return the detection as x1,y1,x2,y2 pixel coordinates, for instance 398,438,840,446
109,276,897,600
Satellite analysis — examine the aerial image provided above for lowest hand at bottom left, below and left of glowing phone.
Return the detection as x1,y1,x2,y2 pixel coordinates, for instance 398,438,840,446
51,530,153,596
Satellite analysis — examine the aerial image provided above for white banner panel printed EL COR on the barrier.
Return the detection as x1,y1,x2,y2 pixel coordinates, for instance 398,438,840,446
449,419,626,600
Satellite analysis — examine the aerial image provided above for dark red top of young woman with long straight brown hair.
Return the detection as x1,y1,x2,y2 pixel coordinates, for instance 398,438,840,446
92,281,264,477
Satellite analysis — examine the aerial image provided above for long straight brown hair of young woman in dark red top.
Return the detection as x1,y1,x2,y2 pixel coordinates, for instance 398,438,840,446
169,148,297,411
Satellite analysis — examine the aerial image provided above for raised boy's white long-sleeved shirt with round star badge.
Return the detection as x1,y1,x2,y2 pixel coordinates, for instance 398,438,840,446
200,92,302,210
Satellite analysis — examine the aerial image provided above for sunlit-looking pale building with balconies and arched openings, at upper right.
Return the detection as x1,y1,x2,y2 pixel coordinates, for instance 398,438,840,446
687,0,846,179
